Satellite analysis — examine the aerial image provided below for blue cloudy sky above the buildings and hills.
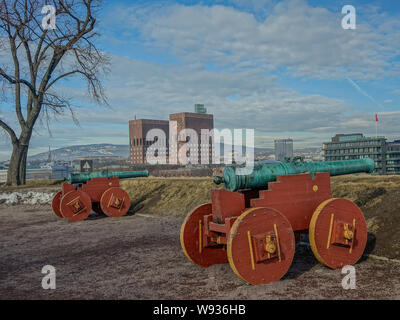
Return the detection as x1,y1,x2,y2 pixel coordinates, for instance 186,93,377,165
0,0,400,159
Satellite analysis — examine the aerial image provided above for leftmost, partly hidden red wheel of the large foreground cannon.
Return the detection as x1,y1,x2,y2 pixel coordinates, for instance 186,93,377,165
180,203,228,267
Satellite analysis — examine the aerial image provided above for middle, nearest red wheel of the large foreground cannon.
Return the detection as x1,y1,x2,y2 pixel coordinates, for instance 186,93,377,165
227,208,295,285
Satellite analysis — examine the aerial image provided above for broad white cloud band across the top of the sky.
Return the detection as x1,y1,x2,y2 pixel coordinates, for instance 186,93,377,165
111,0,400,79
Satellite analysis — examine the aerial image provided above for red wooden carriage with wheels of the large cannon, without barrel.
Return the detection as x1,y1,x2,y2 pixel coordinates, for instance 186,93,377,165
181,173,367,284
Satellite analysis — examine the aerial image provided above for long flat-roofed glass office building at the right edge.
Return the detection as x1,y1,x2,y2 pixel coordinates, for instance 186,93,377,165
322,133,400,174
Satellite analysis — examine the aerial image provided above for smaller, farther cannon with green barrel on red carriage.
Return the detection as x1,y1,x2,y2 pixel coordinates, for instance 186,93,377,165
51,170,149,222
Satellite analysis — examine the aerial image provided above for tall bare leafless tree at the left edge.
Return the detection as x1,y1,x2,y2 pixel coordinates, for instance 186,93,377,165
0,0,109,185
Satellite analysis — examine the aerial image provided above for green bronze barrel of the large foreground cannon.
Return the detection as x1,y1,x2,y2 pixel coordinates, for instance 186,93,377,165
214,157,375,191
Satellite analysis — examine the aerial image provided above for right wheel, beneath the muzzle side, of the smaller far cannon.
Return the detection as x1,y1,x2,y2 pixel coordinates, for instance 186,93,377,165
100,187,131,218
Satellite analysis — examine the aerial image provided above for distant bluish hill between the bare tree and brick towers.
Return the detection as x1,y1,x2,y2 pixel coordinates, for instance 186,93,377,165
29,143,129,161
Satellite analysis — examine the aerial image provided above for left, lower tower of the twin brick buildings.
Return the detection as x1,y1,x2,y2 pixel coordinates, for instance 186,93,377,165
129,119,169,164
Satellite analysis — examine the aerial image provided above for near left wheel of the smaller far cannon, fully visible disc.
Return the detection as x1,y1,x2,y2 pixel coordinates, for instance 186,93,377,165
60,190,92,222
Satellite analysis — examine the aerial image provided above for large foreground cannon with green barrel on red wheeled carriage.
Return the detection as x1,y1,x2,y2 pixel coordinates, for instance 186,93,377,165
180,157,374,285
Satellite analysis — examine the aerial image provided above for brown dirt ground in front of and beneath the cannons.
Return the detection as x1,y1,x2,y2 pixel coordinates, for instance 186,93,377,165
0,205,400,300
